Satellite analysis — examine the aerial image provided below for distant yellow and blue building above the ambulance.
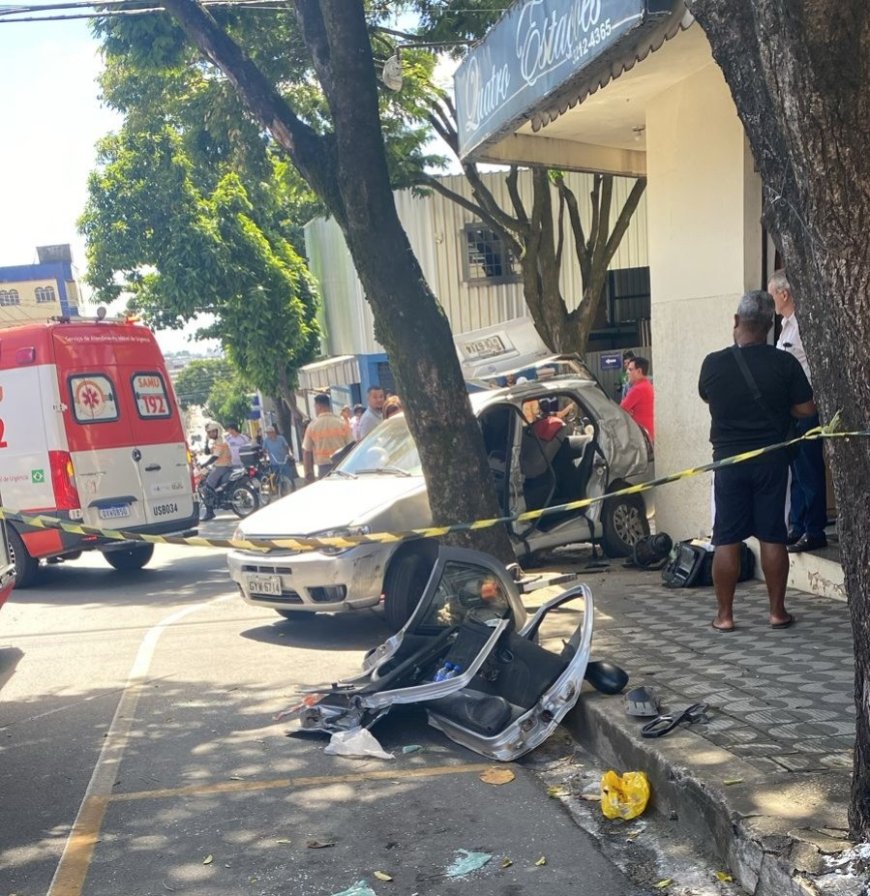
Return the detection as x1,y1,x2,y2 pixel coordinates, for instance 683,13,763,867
0,243,81,327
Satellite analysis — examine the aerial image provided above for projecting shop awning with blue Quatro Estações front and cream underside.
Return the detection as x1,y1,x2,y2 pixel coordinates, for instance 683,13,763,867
454,0,710,175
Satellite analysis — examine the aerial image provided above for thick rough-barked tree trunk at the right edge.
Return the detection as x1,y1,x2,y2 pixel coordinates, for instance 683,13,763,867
688,0,870,840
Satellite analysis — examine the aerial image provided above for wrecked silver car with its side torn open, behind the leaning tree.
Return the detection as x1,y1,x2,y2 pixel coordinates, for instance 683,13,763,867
227,373,652,629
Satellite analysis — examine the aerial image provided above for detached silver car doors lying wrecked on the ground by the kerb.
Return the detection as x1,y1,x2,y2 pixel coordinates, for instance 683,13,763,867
281,547,628,762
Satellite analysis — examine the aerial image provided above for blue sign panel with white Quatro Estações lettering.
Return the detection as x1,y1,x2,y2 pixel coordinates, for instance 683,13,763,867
454,0,673,158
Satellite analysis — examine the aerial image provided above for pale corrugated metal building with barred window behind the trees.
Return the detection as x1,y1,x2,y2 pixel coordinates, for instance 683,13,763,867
299,170,650,413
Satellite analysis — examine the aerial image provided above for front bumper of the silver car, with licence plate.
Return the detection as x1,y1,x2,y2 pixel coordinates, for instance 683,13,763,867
227,544,394,613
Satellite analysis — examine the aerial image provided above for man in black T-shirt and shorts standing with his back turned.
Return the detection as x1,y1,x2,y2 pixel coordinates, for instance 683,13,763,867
698,290,816,632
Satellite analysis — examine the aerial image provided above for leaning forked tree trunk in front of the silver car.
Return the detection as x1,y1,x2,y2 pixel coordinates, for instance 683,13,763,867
166,0,513,561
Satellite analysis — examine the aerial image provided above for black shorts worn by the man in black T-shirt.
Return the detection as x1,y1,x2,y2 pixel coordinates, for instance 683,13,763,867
713,460,788,545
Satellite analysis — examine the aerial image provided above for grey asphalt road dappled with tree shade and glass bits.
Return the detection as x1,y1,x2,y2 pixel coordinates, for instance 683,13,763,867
0,521,638,896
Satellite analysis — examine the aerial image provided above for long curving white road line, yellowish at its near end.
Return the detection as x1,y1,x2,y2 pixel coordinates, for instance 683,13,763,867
46,596,231,896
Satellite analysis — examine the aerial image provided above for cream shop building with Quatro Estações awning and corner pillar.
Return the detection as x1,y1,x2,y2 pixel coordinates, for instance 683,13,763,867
455,0,775,538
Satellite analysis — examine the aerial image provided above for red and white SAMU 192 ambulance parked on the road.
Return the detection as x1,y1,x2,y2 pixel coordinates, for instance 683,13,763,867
0,318,199,588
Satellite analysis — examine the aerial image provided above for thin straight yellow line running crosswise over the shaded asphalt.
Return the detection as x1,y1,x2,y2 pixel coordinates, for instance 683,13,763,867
107,762,492,803
